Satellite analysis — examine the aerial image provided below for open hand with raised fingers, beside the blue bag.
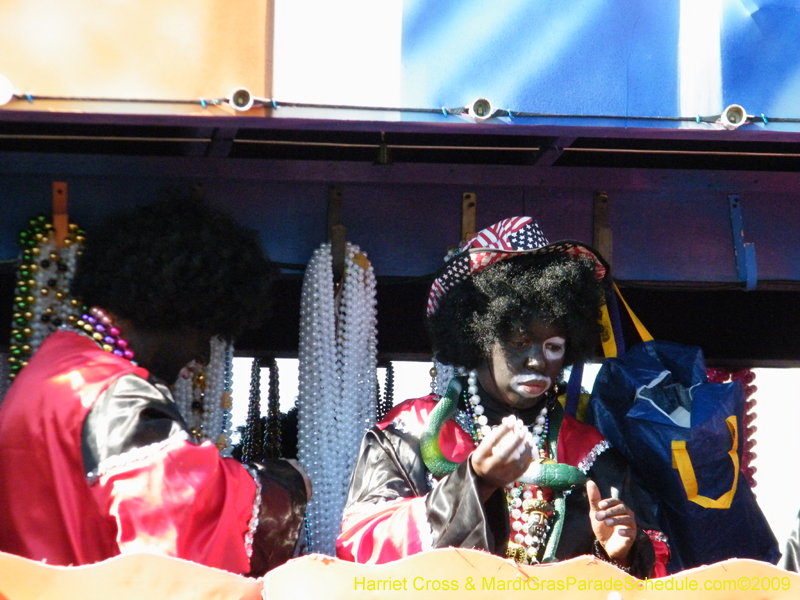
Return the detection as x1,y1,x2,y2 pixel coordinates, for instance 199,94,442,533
586,480,636,566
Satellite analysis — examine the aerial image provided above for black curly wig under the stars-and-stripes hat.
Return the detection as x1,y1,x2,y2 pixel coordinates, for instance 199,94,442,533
427,253,604,369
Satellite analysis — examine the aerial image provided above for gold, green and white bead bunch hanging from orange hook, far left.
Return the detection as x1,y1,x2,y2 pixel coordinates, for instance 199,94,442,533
8,216,84,380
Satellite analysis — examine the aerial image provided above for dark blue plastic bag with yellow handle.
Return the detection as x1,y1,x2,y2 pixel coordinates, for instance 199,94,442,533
587,341,780,572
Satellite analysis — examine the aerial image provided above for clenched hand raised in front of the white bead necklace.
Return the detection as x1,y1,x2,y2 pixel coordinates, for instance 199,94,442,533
470,415,534,502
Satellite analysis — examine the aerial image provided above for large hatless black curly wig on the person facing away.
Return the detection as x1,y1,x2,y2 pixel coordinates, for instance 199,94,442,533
71,189,273,341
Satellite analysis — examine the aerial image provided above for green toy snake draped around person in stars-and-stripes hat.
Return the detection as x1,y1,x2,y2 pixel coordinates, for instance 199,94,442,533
419,377,588,562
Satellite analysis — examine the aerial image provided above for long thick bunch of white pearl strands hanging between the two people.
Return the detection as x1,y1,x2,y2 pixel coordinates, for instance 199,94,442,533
297,244,378,555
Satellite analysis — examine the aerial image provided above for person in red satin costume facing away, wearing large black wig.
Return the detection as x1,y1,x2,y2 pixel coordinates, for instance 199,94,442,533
0,190,309,575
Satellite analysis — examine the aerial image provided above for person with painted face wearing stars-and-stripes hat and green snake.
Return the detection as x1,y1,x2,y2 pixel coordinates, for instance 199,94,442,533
337,217,668,577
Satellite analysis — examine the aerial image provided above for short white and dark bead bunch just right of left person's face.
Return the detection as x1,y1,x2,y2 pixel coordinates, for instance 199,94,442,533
169,337,233,456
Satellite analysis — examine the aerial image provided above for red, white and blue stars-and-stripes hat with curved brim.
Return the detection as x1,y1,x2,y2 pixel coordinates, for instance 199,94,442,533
427,217,608,317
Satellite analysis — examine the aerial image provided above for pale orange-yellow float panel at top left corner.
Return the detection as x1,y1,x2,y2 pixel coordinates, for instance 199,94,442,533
0,0,273,115
